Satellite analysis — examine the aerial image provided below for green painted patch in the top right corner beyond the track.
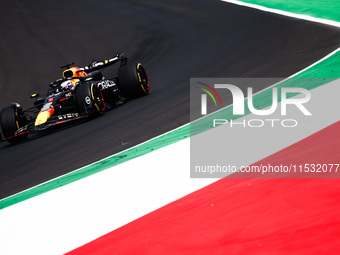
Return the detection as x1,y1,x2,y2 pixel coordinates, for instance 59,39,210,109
235,0,340,21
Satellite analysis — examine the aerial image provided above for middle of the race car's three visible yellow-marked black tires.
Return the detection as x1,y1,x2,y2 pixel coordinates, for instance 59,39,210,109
76,83,105,118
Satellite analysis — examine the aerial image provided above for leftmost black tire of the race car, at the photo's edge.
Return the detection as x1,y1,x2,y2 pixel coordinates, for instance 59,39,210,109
0,106,27,143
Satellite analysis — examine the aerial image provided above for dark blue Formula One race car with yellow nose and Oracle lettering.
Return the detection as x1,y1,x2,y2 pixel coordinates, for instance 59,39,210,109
0,55,150,143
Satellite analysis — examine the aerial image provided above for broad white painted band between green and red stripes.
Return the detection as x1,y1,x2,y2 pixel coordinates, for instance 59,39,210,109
0,81,340,255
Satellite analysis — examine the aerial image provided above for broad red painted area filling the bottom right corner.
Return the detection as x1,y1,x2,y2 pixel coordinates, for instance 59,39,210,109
69,122,340,255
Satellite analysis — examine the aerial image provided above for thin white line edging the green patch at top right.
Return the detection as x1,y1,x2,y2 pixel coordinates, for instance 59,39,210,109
221,0,340,27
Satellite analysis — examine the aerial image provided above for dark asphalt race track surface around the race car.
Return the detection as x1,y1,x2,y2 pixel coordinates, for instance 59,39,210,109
0,0,340,198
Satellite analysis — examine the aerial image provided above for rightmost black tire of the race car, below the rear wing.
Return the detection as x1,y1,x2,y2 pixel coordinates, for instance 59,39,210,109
118,63,150,99
